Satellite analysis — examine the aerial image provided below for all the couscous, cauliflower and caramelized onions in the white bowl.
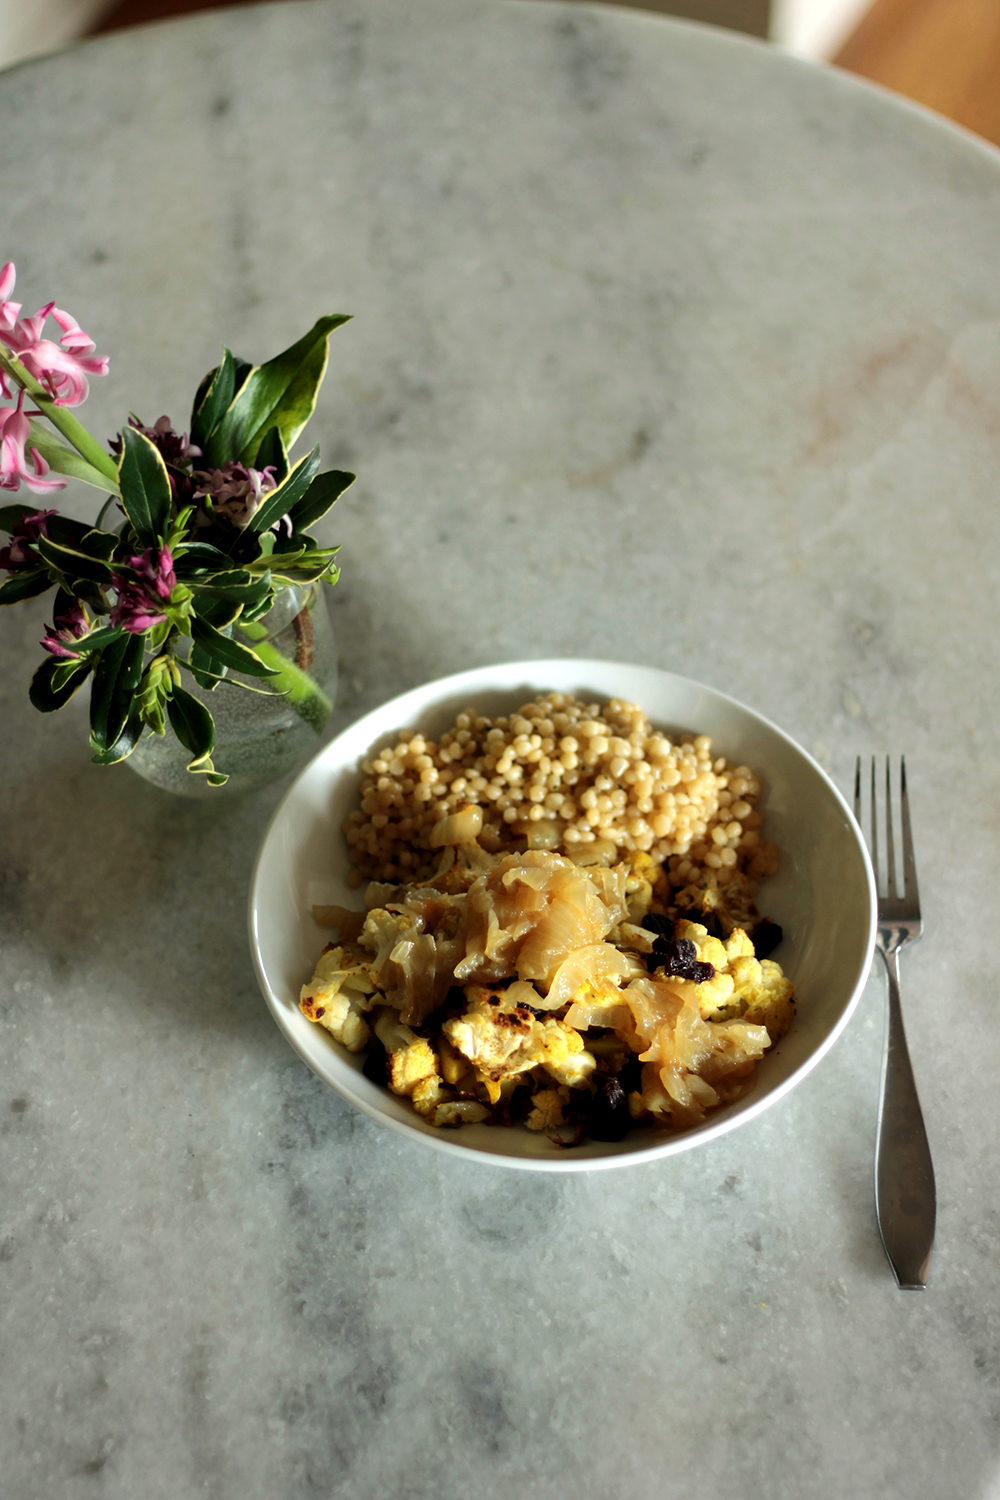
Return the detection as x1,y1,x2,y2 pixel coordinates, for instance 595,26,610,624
300,693,795,1145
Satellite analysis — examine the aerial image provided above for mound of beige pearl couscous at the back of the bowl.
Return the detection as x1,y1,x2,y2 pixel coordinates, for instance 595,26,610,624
343,693,777,887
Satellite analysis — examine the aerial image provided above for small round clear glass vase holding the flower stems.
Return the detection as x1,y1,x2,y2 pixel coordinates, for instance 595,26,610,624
126,584,337,798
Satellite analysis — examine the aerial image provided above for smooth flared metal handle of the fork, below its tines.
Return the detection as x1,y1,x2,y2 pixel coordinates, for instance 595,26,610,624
876,948,936,1289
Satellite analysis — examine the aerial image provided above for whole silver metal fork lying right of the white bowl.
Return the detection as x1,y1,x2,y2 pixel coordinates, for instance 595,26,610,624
855,756,936,1289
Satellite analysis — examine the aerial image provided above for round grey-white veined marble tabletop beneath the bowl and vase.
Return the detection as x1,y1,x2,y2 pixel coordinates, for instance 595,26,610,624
0,0,1000,1500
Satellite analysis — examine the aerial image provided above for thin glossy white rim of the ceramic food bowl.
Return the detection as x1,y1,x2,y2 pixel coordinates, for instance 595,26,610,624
247,657,879,1172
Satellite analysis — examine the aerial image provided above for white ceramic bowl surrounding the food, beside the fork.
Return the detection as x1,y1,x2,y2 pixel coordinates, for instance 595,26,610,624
249,660,876,1172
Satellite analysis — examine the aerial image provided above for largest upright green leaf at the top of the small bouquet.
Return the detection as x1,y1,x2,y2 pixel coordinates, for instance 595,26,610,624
205,314,349,467
